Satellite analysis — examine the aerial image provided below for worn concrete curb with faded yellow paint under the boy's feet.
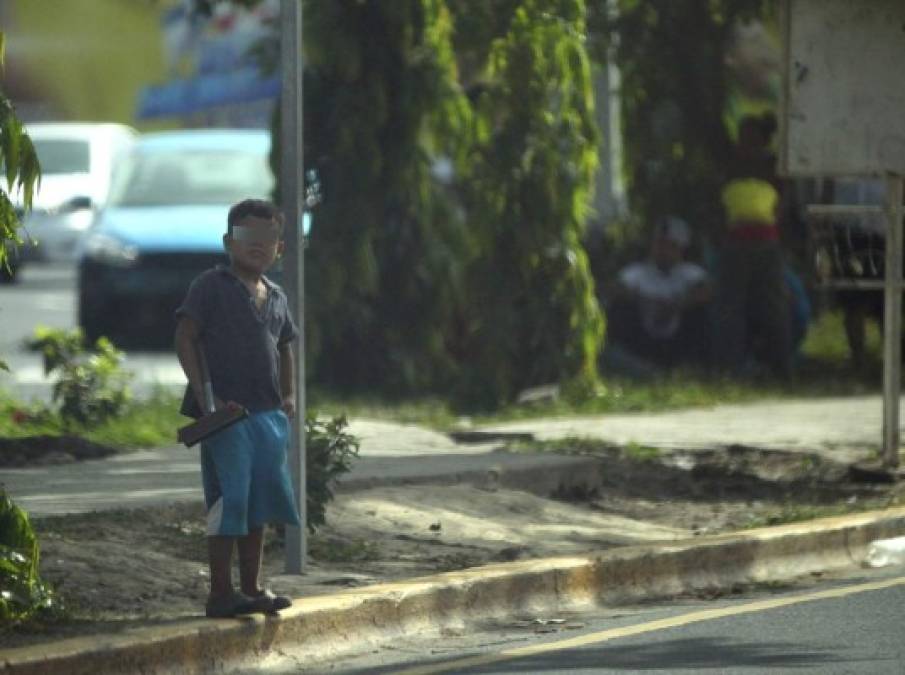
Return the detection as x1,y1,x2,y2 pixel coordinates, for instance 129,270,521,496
7,508,905,675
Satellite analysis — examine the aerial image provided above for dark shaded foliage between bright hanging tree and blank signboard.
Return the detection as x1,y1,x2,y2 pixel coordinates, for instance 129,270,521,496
589,0,776,248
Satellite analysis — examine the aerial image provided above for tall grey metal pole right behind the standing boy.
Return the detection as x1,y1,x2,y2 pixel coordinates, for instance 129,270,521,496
272,0,308,574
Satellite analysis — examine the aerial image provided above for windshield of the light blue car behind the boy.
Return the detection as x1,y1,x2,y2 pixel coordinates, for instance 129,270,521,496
109,150,273,206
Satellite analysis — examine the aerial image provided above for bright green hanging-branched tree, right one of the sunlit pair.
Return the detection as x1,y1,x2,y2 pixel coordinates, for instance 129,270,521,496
456,0,604,405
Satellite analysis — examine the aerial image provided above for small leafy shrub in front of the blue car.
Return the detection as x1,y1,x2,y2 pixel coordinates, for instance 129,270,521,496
27,326,131,427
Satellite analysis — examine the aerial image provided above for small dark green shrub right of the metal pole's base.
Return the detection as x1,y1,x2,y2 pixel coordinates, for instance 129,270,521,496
305,413,359,532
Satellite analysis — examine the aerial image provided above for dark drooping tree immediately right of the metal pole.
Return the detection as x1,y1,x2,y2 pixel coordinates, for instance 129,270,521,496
304,0,471,391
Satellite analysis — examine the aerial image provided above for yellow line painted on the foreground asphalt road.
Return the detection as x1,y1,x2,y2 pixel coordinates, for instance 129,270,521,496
396,577,905,675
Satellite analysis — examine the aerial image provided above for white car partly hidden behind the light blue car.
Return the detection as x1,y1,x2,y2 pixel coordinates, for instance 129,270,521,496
0,122,138,281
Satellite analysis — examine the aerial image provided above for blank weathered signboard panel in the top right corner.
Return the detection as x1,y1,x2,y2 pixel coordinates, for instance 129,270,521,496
780,0,905,176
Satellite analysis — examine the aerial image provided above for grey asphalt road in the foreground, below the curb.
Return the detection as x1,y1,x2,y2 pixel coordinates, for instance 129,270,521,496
306,566,905,675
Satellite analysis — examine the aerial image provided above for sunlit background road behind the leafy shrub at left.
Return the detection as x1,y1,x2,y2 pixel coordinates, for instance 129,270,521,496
0,263,185,400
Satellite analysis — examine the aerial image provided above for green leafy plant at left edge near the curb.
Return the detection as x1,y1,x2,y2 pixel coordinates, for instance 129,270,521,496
0,490,63,628
